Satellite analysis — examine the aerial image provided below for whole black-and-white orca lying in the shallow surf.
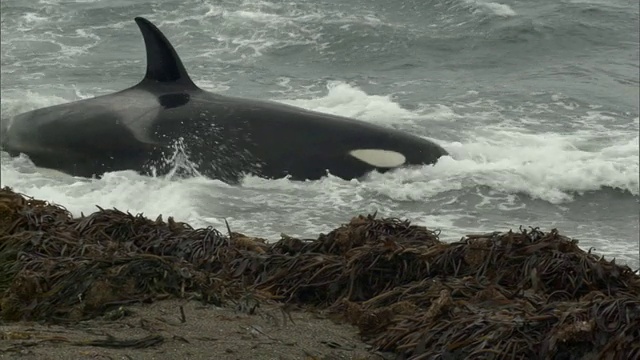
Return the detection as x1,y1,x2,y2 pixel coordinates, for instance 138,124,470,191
2,17,447,183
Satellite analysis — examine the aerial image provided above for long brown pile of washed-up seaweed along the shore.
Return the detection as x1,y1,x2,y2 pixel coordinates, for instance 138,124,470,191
0,188,640,359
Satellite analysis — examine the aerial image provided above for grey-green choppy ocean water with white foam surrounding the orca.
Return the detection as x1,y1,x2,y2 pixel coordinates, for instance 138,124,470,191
0,0,640,268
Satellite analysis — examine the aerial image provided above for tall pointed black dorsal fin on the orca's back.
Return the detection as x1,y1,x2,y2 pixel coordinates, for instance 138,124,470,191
135,17,198,89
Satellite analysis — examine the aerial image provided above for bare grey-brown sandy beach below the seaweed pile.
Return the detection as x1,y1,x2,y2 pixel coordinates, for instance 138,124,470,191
0,300,393,360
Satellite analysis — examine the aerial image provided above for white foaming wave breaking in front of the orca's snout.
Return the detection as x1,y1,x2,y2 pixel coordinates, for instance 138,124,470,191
356,131,639,204
